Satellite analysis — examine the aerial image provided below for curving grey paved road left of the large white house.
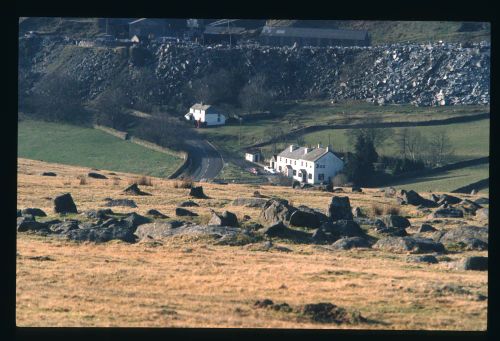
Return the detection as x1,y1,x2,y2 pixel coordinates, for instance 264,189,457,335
179,140,224,181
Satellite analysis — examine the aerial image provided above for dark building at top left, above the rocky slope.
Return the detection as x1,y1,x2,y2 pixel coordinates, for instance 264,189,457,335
129,18,187,39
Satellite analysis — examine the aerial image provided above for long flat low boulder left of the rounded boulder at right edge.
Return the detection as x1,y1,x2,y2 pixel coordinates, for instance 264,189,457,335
373,237,444,253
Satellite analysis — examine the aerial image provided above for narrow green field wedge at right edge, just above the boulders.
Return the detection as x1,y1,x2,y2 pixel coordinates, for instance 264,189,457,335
382,164,489,194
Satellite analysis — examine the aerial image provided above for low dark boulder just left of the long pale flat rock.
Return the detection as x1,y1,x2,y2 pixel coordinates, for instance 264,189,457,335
66,225,136,243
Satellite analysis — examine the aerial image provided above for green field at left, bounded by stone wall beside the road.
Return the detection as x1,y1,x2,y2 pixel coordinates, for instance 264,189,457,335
17,120,182,177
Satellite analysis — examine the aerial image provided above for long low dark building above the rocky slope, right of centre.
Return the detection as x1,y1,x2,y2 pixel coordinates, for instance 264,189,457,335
259,26,370,46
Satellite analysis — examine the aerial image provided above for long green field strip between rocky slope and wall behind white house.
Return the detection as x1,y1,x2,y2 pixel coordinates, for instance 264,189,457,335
202,101,490,154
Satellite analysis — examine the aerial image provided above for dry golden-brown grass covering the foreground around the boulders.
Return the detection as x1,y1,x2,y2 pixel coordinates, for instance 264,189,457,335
16,159,488,330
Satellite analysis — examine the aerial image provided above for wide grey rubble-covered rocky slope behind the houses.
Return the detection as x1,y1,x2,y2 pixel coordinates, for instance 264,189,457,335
19,37,491,106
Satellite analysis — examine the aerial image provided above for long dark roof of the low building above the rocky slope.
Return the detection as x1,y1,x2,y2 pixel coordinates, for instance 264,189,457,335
261,26,368,40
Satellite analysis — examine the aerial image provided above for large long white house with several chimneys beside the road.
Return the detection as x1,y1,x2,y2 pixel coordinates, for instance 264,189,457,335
270,144,344,184
